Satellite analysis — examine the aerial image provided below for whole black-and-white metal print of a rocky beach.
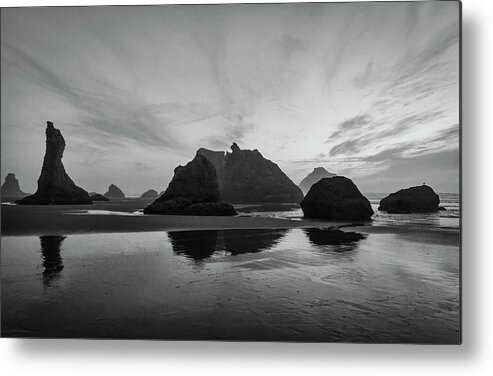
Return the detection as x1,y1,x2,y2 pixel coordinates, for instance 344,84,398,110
1,1,461,344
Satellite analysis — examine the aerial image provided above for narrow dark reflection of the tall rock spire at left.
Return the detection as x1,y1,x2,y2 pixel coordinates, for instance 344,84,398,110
39,235,66,287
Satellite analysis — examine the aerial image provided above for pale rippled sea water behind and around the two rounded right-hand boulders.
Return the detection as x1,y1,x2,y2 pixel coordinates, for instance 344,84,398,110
237,193,460,231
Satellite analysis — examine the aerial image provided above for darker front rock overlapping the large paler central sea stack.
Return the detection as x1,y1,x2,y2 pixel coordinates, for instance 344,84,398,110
144,154,236,216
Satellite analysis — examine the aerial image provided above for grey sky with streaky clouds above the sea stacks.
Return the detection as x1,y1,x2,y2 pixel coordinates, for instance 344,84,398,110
1,1,460,195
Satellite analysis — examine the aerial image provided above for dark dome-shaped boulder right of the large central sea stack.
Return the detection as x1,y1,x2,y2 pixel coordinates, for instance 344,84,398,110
300,176,373,221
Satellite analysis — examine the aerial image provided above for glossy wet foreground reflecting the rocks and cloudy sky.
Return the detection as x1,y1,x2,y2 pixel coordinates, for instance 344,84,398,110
1,228,460,343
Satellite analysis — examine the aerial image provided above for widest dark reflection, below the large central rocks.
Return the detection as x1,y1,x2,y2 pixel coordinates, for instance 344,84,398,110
168,229,289,261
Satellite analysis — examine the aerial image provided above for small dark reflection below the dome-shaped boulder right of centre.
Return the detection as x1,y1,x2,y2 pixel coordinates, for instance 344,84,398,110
303,228,366,253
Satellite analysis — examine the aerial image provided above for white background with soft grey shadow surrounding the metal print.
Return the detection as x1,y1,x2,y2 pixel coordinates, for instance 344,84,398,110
0,0,493,376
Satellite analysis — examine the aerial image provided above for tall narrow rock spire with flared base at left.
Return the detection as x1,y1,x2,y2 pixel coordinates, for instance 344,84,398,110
16,121,92,205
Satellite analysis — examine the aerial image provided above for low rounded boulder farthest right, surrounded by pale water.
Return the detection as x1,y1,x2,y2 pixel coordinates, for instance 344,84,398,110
378,184,440,214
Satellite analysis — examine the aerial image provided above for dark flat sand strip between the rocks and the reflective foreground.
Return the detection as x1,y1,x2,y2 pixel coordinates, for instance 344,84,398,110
1,206,461,246
